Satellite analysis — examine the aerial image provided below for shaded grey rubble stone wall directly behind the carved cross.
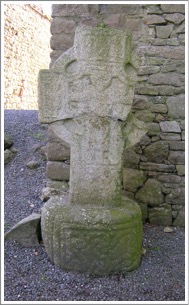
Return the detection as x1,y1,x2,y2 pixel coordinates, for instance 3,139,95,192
47,4,185,226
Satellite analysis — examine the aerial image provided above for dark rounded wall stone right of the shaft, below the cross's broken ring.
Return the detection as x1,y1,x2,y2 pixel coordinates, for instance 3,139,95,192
144,141,169,163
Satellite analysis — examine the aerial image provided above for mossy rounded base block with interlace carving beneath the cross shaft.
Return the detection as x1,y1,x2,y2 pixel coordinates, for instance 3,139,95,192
41,196,142,275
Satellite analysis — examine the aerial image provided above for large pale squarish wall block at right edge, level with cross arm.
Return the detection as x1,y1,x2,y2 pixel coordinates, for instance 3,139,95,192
166,94,185,119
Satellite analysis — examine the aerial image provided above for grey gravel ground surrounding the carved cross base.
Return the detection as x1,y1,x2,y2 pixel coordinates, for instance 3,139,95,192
4,110,185,303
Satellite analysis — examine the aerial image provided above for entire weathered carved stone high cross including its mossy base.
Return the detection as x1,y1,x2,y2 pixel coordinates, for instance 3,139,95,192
39,27,144,274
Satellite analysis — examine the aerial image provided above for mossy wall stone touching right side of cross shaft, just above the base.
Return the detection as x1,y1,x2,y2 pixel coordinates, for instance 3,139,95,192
123,168,147,192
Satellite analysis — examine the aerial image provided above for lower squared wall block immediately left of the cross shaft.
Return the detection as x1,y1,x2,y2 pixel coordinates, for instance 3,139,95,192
46,161,70,181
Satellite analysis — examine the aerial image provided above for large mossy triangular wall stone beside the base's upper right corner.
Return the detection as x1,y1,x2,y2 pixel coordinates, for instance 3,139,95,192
135,178,164,206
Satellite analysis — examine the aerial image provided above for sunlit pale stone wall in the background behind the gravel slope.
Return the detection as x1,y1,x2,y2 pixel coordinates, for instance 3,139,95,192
4,4,51,109
